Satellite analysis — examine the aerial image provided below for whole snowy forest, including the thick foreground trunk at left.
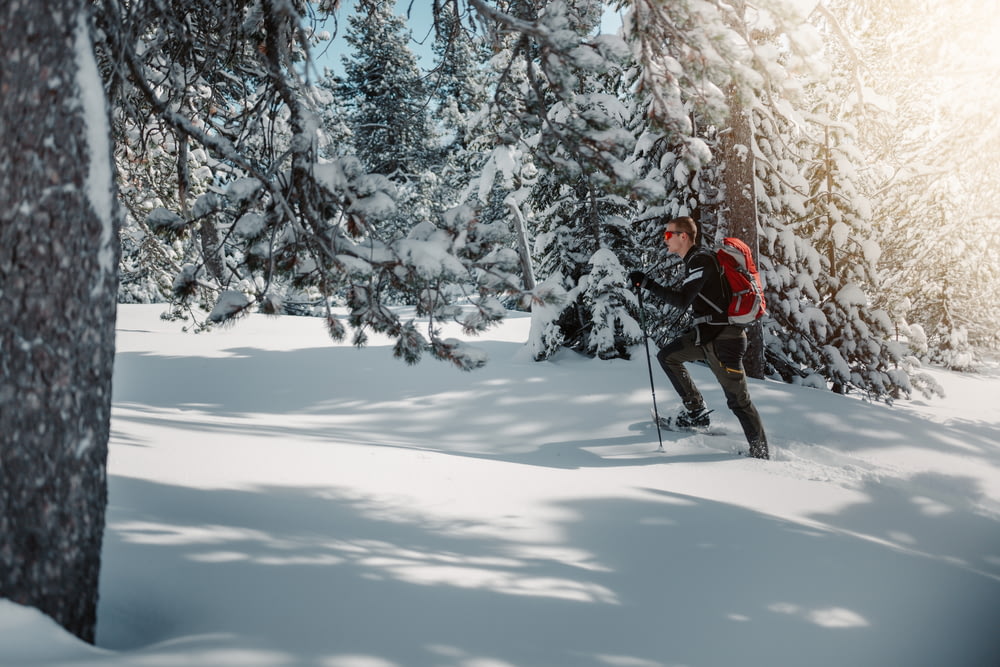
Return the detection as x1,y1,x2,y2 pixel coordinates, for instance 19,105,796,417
0,0,1000,638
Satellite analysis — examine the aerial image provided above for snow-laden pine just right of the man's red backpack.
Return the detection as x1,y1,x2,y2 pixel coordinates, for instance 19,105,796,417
765,101,911,397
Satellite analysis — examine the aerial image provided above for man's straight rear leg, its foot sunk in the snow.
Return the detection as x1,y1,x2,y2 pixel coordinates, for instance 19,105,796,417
705,327,768,459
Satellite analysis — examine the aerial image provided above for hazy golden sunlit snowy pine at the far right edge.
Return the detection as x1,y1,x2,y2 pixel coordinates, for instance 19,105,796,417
830,0,1000,367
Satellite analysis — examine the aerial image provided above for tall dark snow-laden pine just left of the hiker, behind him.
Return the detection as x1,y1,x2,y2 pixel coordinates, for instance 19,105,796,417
472,2,641,359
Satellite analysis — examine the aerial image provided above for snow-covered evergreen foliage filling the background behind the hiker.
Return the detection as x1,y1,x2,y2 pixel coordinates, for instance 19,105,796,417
102,0,998,398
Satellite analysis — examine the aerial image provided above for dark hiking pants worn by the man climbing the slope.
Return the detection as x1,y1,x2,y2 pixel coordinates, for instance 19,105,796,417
656,327,767,458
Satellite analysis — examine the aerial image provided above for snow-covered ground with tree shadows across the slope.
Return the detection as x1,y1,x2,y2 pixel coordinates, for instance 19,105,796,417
0,305,1000,667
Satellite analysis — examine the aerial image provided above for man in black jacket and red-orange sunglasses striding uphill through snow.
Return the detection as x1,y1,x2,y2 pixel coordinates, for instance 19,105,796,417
629,217,768,459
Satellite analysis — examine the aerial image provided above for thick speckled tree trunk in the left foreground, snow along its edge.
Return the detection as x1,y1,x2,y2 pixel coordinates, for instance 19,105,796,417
0,0,118,641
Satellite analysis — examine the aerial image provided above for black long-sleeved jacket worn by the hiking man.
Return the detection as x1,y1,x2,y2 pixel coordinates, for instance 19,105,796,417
643,246,729,345
